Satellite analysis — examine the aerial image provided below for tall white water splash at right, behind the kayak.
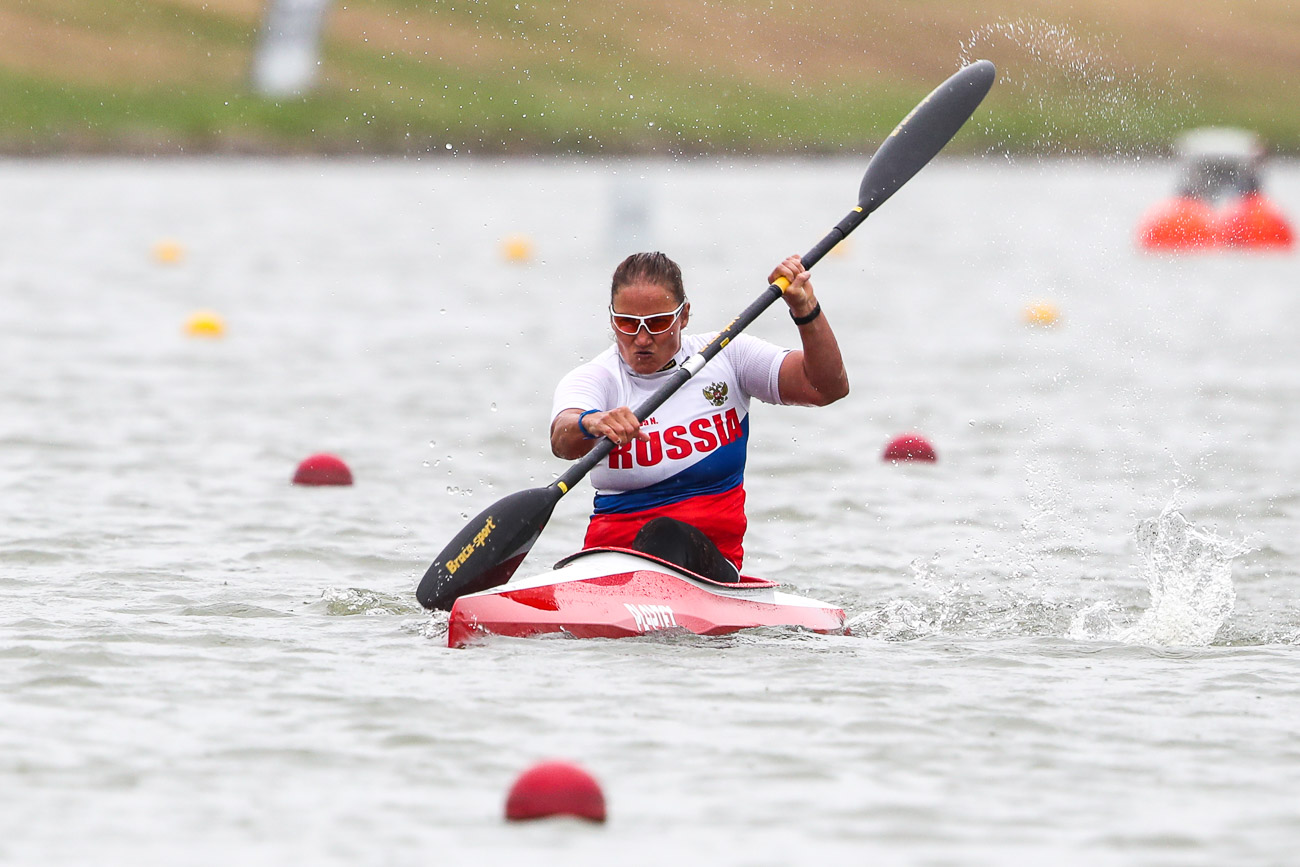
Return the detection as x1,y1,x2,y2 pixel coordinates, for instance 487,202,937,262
1117,508,1249,646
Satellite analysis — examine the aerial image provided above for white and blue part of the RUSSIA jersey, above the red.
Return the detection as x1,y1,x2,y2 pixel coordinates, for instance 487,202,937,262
551,333,789,513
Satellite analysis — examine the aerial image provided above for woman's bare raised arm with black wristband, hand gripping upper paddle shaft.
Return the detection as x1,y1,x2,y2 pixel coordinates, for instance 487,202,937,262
767,256,849,407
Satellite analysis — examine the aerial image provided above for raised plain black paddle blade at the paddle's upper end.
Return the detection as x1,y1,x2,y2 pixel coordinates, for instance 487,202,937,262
858,60,997,217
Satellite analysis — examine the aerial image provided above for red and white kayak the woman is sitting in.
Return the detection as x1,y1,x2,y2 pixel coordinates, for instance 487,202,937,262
447,549,846,647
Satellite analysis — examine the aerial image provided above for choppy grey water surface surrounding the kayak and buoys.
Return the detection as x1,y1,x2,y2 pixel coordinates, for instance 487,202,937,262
0,159,1300,864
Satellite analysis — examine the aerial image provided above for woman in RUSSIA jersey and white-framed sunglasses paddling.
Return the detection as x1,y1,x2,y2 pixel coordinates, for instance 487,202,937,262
551,252,849,581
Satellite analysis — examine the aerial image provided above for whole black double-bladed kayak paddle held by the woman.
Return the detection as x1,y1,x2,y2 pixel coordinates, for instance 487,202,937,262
415,60,996,611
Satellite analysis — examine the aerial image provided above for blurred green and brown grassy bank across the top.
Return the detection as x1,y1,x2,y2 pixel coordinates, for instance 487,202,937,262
0,0,1300,155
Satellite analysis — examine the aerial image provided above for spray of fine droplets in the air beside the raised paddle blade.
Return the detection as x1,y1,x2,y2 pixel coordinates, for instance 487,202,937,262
959,18,1195,155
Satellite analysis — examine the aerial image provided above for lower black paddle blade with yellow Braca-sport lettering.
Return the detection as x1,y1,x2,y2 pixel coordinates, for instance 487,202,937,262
415,486,563,611
